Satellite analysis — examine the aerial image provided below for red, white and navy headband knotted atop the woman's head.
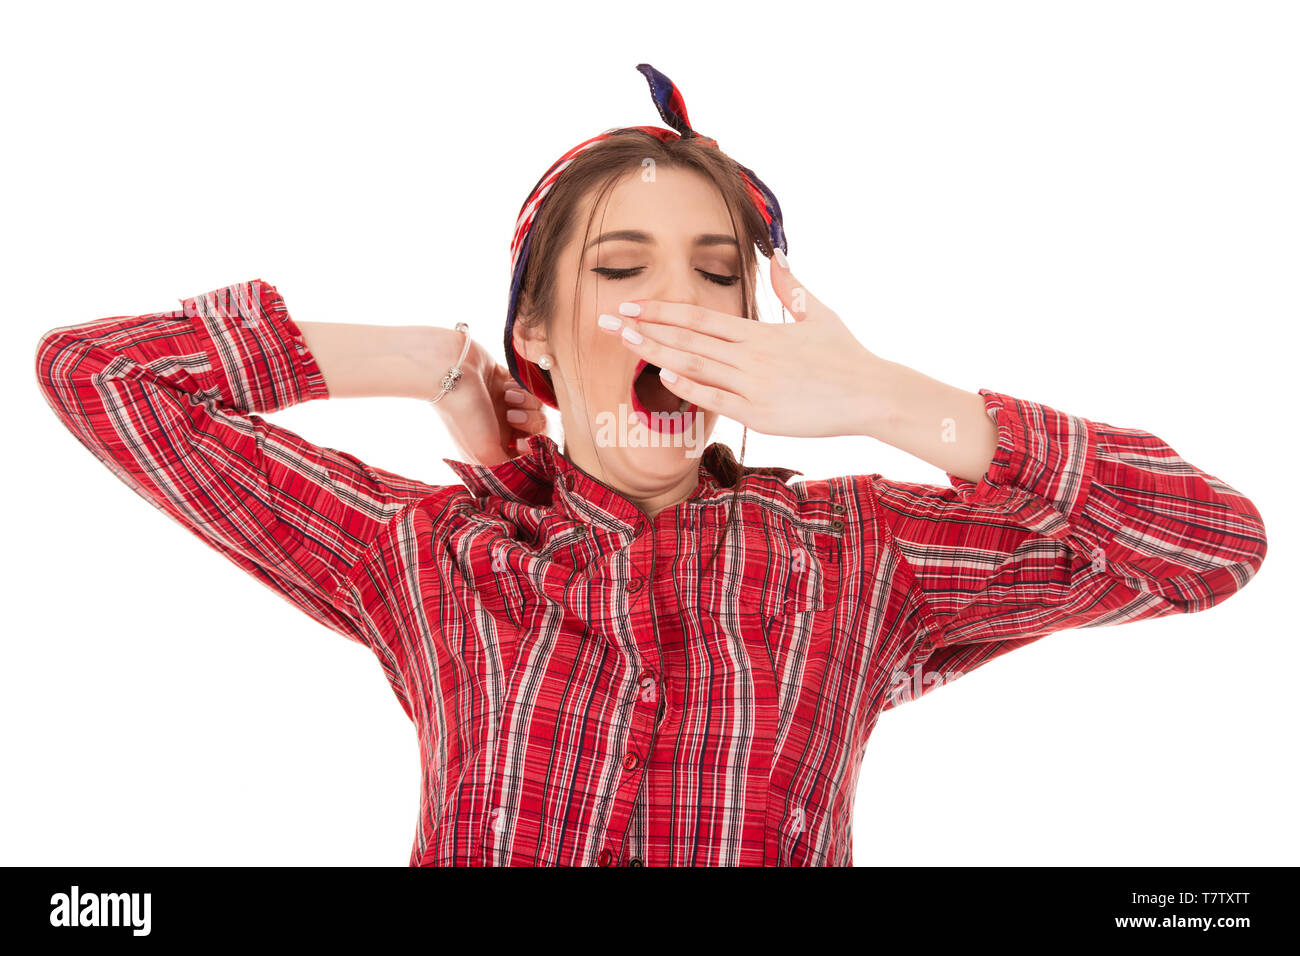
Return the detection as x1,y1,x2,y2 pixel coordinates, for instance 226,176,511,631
506,62,787,408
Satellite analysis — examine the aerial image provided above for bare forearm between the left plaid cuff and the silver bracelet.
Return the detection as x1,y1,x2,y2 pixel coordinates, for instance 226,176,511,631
298,323,464,401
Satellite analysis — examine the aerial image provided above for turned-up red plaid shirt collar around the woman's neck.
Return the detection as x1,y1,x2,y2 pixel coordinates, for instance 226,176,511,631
442,434,803,531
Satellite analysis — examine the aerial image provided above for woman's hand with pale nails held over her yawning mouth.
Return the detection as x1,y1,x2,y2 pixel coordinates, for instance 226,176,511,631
608,251,885,437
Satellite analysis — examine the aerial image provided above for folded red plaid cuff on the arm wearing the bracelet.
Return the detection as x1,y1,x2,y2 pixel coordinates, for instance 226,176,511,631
181,278,329,414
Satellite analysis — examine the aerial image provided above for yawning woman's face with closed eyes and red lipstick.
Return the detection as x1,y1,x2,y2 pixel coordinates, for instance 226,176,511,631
515,166,742,499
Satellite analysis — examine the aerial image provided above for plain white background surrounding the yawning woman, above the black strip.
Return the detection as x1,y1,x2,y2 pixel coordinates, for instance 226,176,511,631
0,0,1300,866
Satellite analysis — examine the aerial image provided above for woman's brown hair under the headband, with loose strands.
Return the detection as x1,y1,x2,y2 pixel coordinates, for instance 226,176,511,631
506,130,772,567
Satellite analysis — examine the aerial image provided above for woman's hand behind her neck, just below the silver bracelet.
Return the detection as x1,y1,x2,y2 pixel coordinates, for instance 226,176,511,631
433,333,546,466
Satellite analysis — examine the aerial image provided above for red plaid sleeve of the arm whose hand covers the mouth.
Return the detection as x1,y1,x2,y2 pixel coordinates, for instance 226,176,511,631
861,389,1268,709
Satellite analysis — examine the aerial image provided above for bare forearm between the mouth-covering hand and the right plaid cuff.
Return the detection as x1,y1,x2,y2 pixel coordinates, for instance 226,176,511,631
862,359,997,481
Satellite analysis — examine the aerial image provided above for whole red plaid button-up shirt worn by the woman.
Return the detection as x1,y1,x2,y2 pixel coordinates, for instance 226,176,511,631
36,281,1266,866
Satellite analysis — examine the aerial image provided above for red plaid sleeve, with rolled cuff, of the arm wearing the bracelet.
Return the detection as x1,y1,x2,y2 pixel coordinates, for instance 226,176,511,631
36,280,438,649
